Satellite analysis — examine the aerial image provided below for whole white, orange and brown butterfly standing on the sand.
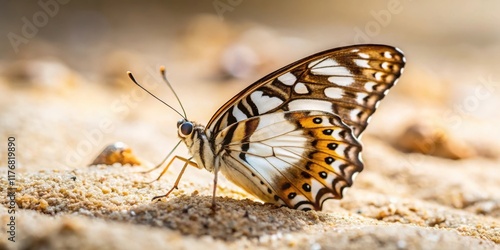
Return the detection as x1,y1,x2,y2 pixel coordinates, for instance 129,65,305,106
128,44,405,211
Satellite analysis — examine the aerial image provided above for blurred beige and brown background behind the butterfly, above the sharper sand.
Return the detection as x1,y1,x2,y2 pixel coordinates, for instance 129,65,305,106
0,0,500,170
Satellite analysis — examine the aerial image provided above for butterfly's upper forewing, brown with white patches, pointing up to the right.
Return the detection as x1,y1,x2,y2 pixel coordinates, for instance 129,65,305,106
207,45,405,137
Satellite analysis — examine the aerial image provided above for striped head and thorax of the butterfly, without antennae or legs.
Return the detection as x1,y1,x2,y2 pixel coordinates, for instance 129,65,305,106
177,119,214,172
